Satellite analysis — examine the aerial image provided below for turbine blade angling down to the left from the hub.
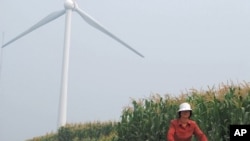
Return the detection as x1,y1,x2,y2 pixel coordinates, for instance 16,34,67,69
2,10,65,48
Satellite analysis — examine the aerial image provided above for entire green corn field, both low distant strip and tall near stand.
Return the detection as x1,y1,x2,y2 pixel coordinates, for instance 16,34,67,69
27,83,250,141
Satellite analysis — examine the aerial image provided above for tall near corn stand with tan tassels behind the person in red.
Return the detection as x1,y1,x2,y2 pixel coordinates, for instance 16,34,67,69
117,81,250,141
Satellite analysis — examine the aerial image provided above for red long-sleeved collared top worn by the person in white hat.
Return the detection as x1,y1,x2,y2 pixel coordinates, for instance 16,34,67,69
167,119,207,141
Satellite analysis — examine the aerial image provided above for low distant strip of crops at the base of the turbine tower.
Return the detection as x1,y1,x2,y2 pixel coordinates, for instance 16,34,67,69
29,121,117,141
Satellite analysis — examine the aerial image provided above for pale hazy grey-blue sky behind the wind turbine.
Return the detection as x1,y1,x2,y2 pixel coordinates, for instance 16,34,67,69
0,0,250,141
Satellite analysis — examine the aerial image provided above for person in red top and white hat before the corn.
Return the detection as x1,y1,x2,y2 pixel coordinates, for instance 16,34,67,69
167,103,207,141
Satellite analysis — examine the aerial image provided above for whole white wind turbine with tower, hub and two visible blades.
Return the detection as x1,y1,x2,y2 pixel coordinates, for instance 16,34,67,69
2,0,144,127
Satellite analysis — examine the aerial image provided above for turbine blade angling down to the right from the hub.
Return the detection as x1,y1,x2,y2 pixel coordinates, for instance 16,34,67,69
75,7,144,57
